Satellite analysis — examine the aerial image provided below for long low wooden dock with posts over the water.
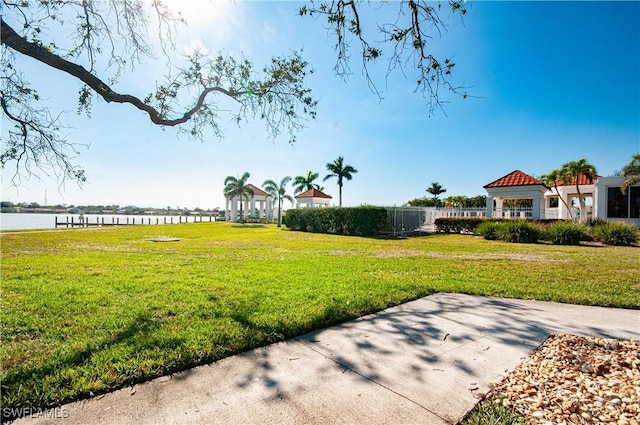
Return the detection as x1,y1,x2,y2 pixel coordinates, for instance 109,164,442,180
55,215,217,228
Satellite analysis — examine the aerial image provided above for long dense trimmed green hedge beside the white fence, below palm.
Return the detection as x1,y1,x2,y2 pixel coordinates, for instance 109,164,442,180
282,206,387,236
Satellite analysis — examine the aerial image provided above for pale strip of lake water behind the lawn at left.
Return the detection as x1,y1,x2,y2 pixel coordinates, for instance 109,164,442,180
0,213,215,231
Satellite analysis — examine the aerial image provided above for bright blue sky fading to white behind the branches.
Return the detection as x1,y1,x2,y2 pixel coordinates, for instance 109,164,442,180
2,0,640,208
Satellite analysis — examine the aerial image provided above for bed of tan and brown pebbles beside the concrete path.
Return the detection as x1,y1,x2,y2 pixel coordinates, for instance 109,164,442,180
487,334,640,425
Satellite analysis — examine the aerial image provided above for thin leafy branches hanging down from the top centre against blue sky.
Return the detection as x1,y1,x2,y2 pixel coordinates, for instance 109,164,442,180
299,0,468,113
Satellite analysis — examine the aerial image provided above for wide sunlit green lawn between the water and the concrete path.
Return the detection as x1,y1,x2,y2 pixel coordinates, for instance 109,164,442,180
0,223,640,414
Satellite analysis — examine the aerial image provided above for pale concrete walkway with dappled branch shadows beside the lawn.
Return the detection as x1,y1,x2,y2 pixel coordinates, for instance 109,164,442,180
14,294,640,425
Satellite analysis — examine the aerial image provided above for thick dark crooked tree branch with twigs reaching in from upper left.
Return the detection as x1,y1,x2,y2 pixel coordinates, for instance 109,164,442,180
0,0,317,182
